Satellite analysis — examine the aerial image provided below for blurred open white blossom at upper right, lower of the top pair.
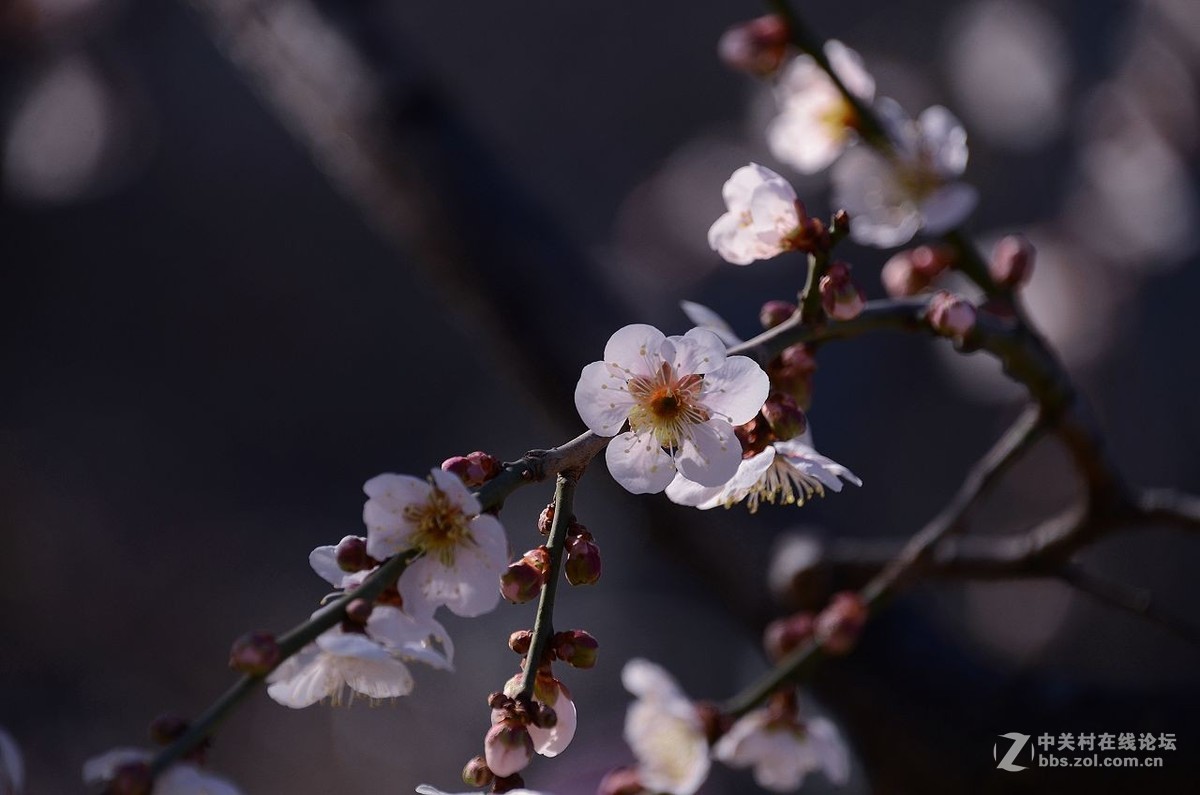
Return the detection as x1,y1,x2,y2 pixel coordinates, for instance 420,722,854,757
833,101,978,249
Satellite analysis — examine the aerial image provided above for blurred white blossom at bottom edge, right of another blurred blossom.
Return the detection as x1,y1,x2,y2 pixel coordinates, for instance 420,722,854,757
713,710,850,793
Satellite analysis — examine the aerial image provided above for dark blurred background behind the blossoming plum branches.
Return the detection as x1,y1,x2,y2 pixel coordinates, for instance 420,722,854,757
0,0,1200,795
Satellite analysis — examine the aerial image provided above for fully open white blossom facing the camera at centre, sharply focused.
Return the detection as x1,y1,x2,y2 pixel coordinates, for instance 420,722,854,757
573,324,769,492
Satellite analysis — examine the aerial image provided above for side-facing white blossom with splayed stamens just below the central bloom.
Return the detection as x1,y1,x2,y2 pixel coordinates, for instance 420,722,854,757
667,429,863,513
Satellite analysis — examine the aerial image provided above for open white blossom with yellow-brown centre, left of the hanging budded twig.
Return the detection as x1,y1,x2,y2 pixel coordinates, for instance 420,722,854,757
362,468,509,617
